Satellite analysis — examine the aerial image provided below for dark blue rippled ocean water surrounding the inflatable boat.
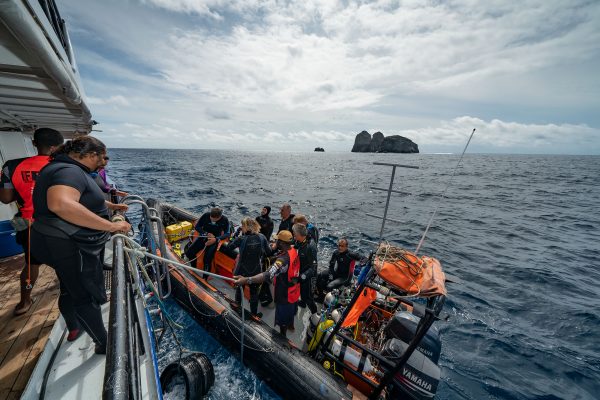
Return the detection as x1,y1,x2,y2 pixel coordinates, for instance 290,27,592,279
108,149,600,399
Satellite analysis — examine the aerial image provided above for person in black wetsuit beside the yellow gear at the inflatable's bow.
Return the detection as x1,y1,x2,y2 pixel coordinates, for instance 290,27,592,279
185,207,231,271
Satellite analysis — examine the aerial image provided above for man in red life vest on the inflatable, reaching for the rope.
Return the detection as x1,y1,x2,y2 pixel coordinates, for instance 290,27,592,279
233,230,300,336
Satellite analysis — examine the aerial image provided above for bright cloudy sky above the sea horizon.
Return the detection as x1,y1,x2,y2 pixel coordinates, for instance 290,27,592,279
57,0,600,154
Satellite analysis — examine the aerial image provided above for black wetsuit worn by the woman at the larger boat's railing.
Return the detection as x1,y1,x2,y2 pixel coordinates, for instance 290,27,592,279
31,154,110,348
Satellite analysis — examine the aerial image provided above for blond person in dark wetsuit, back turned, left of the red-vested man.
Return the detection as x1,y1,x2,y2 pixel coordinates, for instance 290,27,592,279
225,217,270,318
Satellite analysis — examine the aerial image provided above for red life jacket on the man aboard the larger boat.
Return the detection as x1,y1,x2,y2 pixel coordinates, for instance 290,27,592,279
10,156,50,220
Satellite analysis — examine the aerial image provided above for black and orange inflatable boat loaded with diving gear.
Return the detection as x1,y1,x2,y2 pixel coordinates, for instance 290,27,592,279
141,200,446,399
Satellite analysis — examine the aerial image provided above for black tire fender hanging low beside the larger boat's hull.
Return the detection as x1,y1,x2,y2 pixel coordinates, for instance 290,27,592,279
160,353,215,400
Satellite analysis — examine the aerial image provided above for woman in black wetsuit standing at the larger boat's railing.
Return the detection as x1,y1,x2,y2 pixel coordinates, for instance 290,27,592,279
31,136,131,354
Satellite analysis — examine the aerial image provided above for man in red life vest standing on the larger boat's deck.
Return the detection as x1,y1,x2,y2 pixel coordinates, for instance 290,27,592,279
0,128,63,316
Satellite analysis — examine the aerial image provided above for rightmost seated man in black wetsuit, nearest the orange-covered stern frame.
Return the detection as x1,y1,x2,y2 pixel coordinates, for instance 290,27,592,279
317,238,363,292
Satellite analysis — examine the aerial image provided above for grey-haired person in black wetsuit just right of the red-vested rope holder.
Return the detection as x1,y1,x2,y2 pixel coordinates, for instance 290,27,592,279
292,223,317,314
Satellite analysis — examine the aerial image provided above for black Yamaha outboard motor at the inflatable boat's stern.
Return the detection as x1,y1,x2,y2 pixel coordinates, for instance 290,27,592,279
381,311,442,400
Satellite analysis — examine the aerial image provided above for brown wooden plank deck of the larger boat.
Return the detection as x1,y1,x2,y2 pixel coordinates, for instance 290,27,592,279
0,255,60,399
